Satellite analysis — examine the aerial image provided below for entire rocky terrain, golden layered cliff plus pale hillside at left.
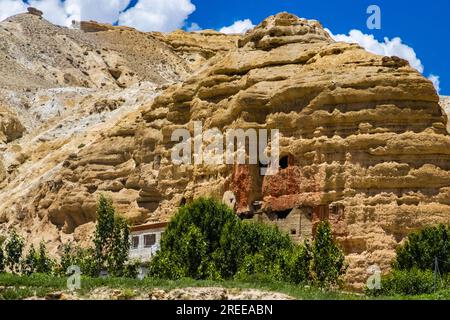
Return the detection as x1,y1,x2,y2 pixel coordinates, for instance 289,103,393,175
0,13,450,287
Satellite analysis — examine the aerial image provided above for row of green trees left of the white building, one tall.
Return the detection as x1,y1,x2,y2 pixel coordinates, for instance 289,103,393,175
0,196,139,277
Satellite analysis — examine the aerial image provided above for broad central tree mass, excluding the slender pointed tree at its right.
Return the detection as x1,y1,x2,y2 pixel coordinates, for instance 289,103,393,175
149,198,304,280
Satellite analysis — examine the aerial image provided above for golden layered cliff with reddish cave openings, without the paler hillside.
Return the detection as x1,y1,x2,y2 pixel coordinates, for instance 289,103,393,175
0,13,450,287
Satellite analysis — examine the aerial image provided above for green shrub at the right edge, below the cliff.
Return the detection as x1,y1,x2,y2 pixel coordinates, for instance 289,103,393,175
394,225,450,273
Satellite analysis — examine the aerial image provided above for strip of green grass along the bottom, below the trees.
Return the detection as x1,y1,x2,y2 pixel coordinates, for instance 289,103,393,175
0,274,450,300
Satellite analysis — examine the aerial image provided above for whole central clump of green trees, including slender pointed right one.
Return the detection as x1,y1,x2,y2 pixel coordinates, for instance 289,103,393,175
149,198,346,286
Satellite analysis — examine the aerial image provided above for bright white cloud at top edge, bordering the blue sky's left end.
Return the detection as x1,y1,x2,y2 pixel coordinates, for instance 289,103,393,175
119,0,195,32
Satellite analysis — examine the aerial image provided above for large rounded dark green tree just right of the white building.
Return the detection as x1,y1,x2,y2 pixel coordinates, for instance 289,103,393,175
149,199,241,279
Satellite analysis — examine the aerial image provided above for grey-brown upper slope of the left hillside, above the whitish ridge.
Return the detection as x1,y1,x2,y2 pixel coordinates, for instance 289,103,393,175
0,14,193,91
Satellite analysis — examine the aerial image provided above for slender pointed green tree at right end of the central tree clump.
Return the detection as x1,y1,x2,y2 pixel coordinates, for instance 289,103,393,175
311,221,346,287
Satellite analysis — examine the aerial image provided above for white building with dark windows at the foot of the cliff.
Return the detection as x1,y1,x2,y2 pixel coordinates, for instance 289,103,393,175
129,222,167,262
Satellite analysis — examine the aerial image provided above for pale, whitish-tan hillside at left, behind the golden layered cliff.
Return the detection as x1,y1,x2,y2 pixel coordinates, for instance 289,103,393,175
0,14,237,245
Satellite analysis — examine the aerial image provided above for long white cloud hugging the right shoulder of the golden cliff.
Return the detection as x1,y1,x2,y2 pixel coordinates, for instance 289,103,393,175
327,29,424,73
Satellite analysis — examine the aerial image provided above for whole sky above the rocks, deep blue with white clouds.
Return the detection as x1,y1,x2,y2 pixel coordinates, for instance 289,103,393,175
0,0,450,95
